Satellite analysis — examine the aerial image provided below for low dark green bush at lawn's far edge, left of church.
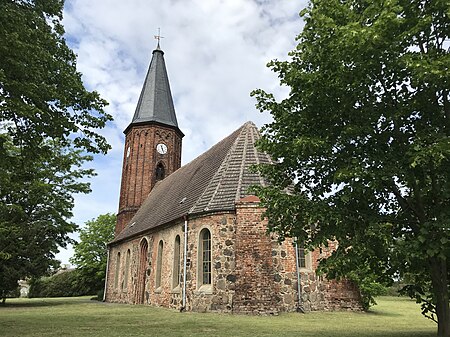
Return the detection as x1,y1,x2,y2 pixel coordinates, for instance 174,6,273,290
28,269,92,297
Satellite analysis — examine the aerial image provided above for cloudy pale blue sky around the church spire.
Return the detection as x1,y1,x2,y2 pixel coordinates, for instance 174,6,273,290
56,0,307,264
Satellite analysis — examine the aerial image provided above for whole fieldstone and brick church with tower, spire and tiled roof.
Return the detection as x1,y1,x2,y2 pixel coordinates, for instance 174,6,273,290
105,44,360,314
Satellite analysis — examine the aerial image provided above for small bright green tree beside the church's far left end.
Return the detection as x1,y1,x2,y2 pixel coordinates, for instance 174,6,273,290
70,213,116,293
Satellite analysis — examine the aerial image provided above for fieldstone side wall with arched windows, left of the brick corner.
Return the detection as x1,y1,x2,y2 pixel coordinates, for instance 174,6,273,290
106,212,236,312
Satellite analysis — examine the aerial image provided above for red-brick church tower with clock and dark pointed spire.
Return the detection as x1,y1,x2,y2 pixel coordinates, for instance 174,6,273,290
115,41,184,236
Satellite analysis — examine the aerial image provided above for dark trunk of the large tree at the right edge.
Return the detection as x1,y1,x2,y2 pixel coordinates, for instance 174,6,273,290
430,257,450,337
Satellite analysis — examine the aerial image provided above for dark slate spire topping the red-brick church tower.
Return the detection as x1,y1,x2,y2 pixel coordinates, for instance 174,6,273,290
125,41,178,132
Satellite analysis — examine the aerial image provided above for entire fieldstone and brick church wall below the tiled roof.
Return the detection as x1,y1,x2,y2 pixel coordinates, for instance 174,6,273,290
106,197,361,314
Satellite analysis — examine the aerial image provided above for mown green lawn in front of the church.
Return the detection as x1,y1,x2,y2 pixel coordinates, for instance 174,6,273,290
0,297,436,337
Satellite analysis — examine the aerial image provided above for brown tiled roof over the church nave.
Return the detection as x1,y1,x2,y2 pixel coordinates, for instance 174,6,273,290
113,122,270,242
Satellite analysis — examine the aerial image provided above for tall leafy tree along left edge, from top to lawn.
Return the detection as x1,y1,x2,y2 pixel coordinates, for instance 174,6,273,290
0,0,112,298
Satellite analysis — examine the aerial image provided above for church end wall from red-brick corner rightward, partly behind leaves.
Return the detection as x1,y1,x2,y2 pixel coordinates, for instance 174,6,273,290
230,196,362,314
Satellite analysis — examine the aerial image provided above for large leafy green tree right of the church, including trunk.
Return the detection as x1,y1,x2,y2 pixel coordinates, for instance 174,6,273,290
253,0,450,336
